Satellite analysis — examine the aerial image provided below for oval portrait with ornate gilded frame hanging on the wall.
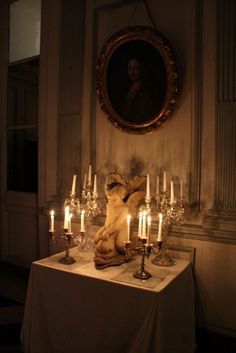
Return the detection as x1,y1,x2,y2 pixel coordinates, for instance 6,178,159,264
96,26,179,134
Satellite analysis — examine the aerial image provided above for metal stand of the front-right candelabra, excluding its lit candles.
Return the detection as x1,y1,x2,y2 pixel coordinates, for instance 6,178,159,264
124,238,158,280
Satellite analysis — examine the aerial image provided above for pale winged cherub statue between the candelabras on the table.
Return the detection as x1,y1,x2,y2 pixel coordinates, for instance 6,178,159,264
94,173,146,269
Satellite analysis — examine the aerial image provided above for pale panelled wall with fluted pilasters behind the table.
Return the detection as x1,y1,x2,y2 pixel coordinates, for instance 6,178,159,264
1,0,236,335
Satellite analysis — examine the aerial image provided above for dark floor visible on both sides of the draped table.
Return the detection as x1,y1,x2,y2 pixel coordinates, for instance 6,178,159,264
0,262,236,353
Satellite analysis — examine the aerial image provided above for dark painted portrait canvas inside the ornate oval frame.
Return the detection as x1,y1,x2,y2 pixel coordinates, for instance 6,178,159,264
107,40,167,123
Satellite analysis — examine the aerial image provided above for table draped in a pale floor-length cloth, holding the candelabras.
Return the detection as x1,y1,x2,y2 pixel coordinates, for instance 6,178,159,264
21,247,195,353
